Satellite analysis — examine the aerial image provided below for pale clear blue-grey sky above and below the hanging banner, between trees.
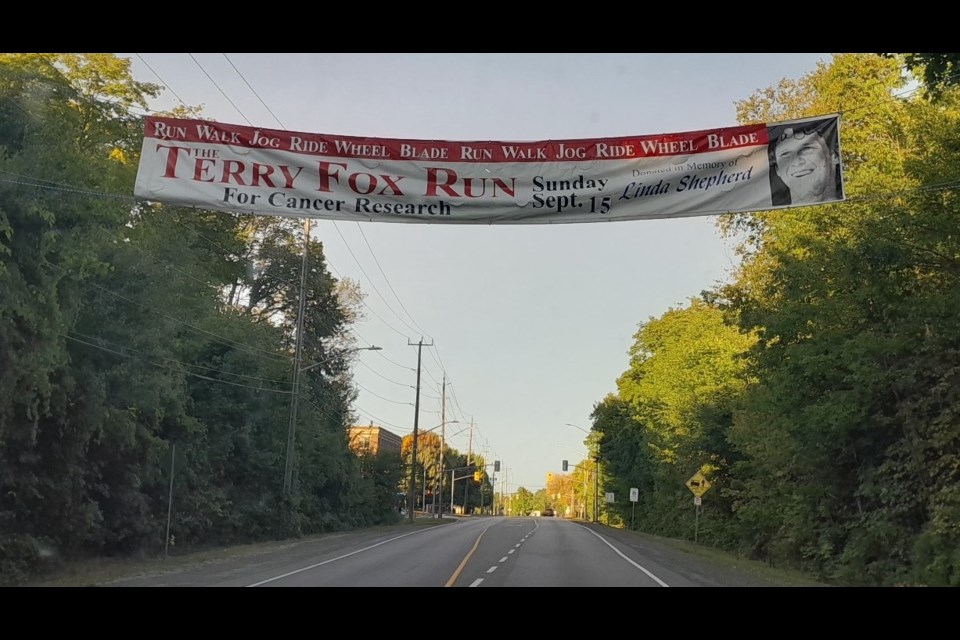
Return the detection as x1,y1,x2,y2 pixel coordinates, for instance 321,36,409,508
117,53,830,491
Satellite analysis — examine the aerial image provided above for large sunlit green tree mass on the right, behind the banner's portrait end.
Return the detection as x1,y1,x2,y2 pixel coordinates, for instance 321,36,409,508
720,54,960,584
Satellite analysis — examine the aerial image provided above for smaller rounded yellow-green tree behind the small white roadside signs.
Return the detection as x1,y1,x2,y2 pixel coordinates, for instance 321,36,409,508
608,299,754,544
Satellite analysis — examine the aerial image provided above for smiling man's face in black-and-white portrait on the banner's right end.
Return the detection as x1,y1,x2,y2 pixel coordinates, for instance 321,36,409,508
776,133,834,203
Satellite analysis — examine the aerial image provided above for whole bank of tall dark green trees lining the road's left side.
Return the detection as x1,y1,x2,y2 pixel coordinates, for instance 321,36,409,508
0,54,376,582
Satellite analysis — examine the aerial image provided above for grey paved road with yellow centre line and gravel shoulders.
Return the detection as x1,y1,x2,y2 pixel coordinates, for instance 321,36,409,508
103,517,808,587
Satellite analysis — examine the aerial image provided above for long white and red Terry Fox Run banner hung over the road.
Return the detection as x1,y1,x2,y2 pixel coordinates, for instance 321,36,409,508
134,115,844,224
